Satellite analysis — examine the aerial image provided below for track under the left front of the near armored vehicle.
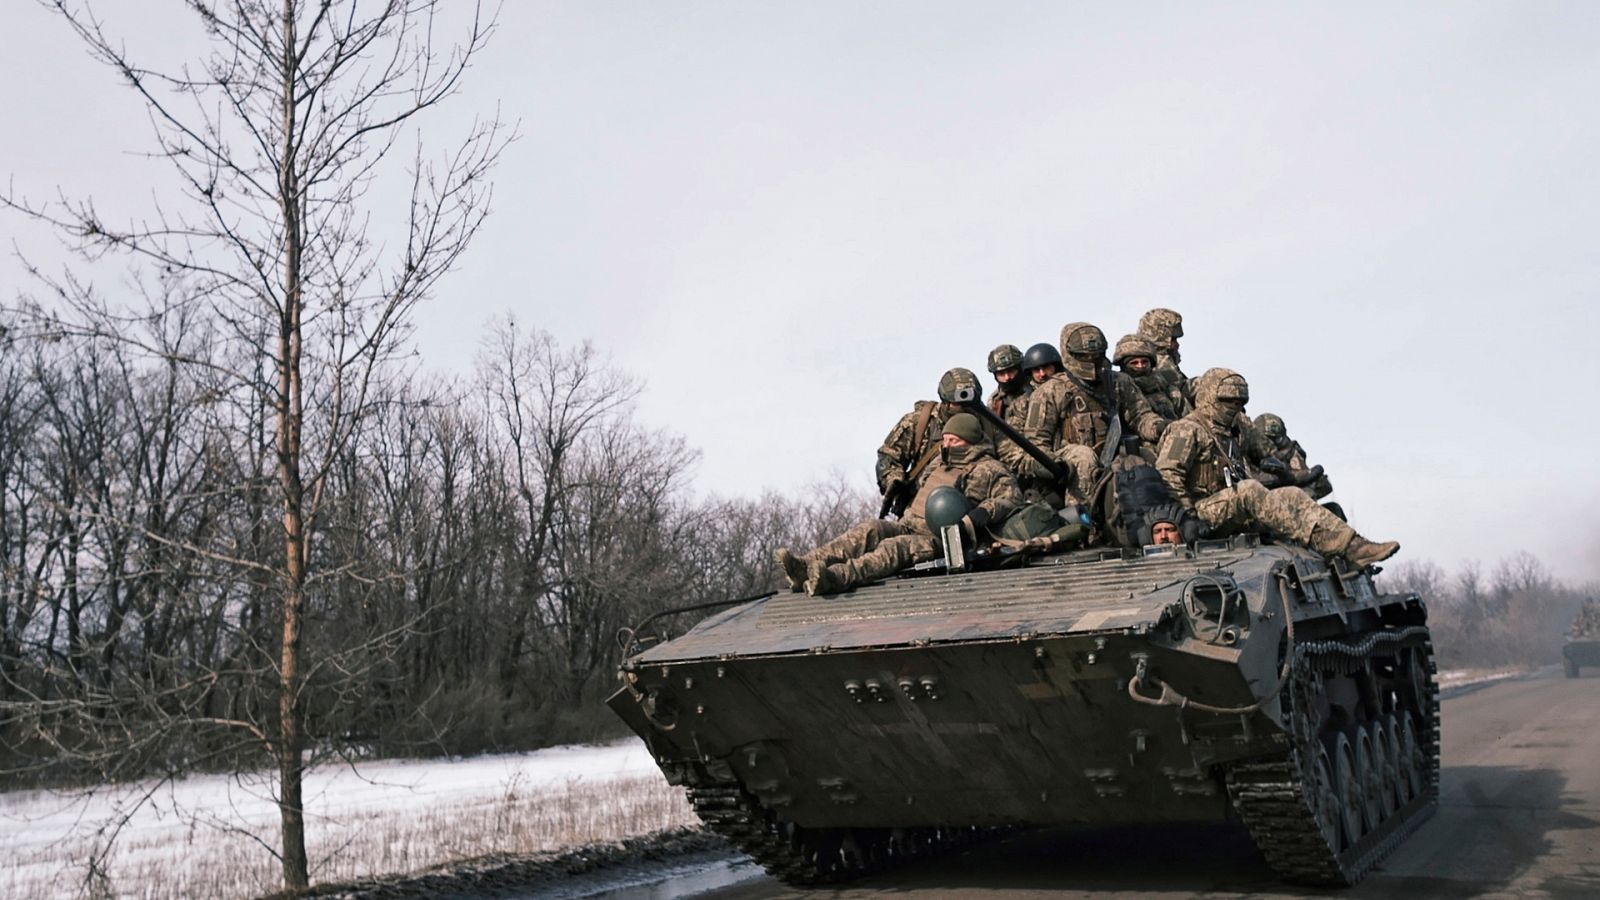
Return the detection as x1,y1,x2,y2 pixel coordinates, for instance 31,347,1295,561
690,785,979,886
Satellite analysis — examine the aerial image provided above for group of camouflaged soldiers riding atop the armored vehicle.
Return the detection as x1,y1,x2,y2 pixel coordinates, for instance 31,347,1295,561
776,309,1400,594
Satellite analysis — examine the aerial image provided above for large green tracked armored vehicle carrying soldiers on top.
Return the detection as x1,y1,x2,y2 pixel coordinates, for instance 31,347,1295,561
610,536,1438,886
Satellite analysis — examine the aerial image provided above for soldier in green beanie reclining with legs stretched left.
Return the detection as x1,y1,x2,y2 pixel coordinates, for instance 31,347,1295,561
773,413,1022,596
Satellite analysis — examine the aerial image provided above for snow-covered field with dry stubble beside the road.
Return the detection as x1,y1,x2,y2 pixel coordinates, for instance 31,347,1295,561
0,669,1518,898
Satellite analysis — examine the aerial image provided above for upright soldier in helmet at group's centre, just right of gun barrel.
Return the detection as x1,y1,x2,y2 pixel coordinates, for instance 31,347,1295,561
1022,322,1166,503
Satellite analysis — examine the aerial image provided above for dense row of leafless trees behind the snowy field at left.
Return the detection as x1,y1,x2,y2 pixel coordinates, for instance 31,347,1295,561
0,319,870,786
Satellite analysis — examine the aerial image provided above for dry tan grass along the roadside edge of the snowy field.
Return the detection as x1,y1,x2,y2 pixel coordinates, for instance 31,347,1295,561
0,775,699,900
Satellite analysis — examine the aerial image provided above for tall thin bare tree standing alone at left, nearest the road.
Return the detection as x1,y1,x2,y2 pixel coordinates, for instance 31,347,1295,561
0,0,510,889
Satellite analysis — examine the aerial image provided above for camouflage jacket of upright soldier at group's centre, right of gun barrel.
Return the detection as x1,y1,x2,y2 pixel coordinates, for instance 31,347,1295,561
1022,372,1166,458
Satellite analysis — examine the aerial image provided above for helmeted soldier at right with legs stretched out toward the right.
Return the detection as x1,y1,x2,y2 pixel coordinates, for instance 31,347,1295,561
1155,368,1400,569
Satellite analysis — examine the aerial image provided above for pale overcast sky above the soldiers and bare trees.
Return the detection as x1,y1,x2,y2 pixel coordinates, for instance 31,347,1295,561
0,0,1600,578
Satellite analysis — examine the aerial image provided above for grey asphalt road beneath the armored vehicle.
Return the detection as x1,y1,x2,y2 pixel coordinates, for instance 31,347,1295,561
688,669,1600,900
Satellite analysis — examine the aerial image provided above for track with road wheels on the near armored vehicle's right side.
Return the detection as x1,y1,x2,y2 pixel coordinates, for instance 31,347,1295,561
1227,626,1438,886
